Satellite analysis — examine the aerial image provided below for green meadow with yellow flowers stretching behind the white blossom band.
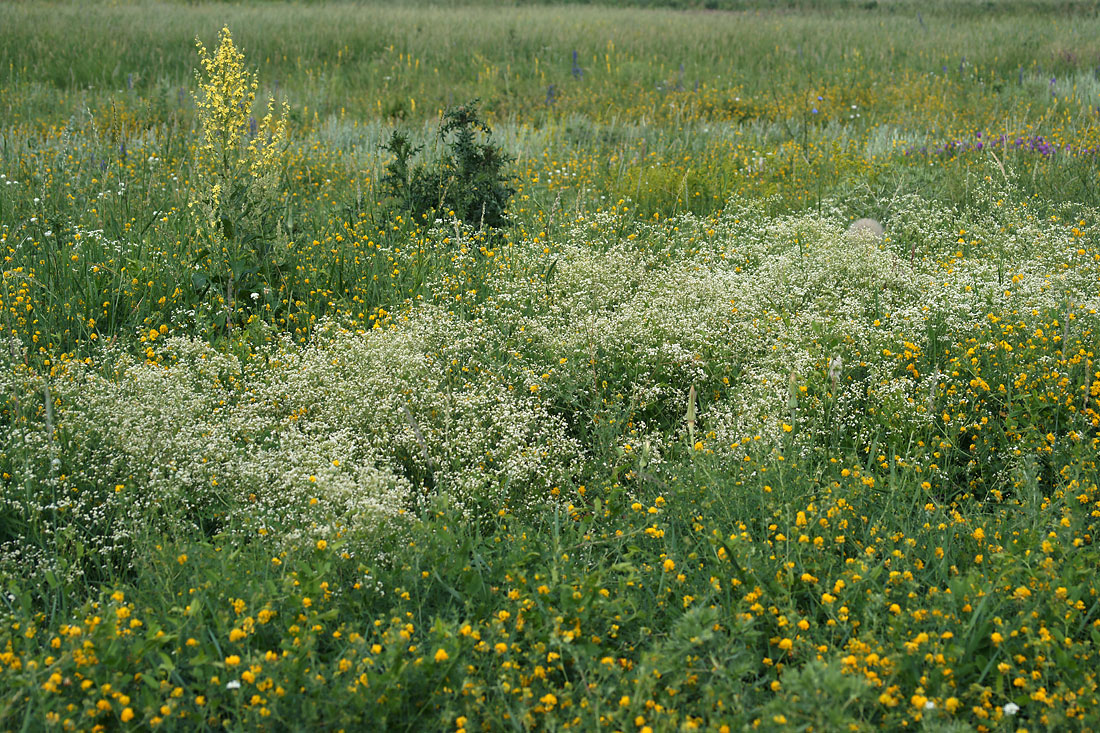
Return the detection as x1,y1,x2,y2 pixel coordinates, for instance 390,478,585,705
0,3,1100,350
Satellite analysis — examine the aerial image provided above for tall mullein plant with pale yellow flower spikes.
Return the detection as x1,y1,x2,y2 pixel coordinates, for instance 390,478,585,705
190,28,289,330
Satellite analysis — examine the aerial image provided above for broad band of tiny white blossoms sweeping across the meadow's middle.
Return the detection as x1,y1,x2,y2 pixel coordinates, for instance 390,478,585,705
0,169,1100,581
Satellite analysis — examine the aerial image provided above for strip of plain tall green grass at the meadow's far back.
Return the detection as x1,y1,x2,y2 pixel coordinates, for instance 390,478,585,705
0,3,1100,117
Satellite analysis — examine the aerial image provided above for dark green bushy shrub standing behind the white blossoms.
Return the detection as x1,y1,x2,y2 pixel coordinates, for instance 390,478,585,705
380,101,516,227
